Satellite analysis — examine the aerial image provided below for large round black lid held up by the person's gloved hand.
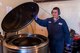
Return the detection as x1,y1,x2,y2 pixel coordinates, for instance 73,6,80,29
1,2,39,32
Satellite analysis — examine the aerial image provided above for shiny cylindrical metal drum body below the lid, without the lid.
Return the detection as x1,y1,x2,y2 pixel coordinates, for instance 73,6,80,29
3,34,49,53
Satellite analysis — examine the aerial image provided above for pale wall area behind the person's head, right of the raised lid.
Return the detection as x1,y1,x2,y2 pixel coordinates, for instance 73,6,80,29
38,0,80,34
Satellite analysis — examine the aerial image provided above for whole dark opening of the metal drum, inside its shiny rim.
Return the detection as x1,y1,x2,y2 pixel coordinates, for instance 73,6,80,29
6,34,47,46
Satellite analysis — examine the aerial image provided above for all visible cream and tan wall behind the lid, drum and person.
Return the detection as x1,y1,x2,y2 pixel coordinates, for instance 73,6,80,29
0,0,80,35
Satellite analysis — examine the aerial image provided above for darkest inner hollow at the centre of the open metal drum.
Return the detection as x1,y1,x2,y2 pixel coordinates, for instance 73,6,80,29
12,37,41,46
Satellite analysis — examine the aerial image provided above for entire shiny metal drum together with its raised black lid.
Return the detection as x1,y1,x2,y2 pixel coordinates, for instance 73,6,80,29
1,2,49,53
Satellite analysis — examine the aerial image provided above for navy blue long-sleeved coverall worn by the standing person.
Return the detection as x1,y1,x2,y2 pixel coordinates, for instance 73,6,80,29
36,16,70,53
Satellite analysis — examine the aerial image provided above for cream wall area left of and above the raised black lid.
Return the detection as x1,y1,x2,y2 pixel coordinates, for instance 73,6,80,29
0,0,33,34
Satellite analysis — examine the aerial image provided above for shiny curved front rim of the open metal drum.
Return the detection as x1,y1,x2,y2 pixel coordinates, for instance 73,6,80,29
3,34,49,50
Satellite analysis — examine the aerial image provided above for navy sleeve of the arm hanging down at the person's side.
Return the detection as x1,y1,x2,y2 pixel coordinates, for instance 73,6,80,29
63,21,71,44
